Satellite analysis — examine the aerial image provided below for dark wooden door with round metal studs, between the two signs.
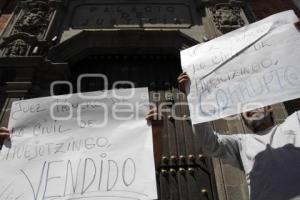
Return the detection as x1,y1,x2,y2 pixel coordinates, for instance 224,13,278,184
71,55,217,200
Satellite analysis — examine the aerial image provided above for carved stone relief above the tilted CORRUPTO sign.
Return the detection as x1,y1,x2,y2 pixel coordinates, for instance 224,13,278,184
211,4,245,33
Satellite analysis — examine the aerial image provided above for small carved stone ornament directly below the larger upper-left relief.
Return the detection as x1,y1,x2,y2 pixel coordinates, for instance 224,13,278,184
4,39,29,57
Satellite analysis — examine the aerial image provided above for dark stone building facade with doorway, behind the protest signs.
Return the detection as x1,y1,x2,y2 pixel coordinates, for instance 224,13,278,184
0,0,294,200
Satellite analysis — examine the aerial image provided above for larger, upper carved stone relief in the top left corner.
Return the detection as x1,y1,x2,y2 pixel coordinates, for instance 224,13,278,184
14,2,50,35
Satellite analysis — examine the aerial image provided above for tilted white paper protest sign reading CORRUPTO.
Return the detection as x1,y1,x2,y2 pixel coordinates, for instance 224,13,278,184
181,11,300,124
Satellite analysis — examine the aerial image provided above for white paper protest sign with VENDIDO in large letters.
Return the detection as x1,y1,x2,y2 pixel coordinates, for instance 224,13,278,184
0,88,157,200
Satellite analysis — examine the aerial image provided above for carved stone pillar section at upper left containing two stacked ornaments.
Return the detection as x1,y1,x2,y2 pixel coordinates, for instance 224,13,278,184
0,0,57,57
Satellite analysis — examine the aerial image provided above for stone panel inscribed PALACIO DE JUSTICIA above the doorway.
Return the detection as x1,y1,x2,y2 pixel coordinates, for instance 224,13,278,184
68,1,193,29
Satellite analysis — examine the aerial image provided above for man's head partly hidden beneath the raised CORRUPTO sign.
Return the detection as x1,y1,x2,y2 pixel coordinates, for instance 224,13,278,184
242,106,274,133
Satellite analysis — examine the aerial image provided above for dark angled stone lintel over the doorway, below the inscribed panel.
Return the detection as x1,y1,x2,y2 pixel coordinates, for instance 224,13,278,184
49,30,198,63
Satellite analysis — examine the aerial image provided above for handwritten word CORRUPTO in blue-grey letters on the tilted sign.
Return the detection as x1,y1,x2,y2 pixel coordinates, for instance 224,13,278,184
190,66,300,118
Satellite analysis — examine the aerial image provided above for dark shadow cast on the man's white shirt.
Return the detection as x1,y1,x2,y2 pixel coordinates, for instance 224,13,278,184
250,144,300,200
